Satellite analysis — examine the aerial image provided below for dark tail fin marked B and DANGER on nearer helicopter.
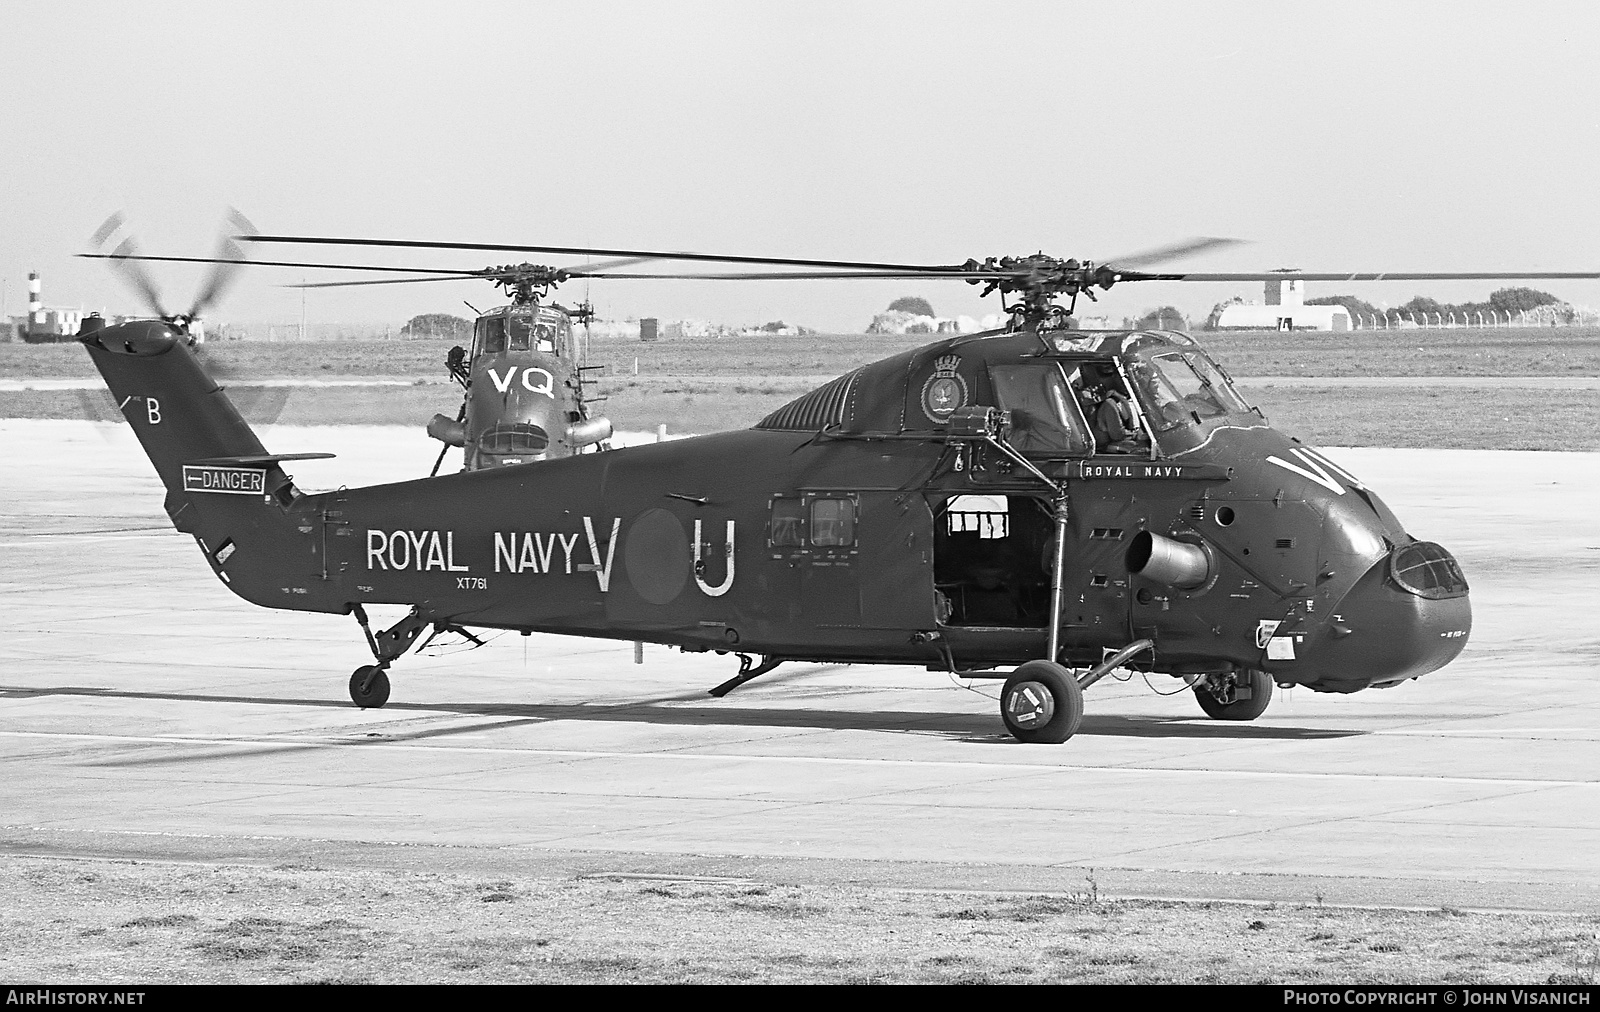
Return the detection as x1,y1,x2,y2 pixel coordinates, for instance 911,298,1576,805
78,320,344,612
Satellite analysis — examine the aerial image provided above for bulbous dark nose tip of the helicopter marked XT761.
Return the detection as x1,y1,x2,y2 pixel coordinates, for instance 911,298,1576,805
1318,541,1472,690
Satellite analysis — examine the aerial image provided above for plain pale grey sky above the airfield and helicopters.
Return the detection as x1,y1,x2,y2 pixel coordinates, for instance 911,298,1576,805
0,0,1600,330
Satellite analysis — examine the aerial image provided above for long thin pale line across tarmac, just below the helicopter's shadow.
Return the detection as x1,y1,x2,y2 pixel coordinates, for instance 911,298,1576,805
0,730,1600,788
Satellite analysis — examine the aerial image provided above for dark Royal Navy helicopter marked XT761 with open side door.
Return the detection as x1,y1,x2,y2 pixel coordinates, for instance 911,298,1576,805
80,237,1600,741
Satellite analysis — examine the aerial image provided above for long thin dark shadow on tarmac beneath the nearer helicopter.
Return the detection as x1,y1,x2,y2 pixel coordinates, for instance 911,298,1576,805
0,685,1371,756
